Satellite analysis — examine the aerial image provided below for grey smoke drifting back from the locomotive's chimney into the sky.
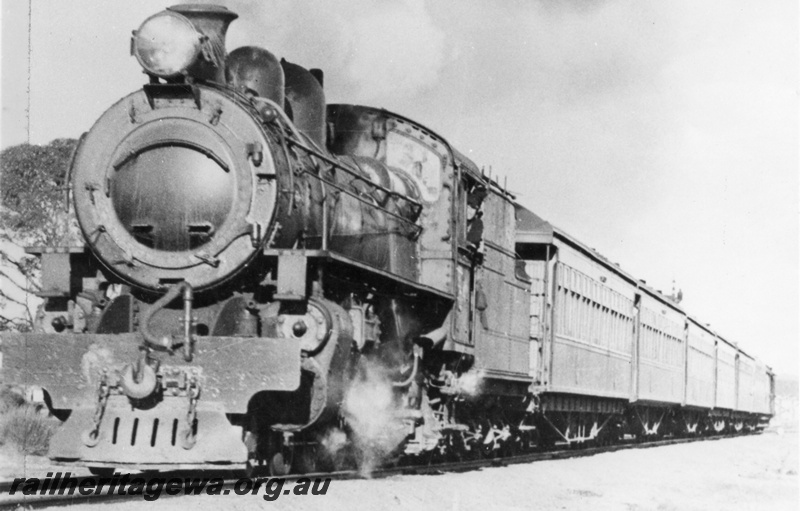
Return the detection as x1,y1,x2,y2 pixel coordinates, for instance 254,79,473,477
193,0,445,103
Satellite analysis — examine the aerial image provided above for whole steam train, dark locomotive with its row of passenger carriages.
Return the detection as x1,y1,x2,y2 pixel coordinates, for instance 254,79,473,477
2,5,774,474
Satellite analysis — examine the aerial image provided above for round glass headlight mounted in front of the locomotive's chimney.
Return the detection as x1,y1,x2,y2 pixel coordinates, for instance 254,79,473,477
133,11,202,78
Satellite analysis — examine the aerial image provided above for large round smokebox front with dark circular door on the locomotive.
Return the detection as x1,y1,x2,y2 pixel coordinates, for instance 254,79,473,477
72,80,291,291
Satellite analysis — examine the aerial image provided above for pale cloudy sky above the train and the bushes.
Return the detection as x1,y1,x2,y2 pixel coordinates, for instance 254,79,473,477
0,0,800,375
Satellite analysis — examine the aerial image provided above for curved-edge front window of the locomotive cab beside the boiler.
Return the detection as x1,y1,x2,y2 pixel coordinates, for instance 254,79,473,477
386,131,442,202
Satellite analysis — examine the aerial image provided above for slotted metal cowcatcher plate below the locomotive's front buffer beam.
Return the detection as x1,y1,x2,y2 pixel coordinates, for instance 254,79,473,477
48,395,247,469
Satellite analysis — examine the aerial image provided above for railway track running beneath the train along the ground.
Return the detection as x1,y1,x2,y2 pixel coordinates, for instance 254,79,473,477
0,431,761,510
